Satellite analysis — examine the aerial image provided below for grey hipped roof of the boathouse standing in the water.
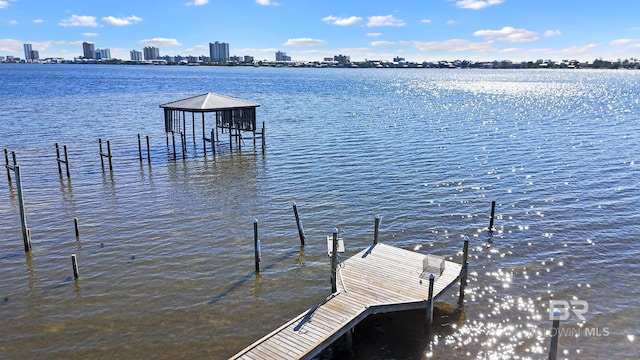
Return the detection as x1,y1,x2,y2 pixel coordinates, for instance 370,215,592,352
160,92,260,112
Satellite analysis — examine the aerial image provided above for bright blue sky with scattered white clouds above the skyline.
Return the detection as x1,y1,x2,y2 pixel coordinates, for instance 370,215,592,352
0,0,640,62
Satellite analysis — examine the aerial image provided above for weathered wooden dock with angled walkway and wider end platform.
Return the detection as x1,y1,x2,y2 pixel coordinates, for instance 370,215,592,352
231,244,467,360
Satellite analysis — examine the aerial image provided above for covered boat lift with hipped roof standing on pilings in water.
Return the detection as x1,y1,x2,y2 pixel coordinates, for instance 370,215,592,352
160,92,265,155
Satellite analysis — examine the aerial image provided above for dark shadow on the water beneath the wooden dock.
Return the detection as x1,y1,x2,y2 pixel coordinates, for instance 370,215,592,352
316,302,466,360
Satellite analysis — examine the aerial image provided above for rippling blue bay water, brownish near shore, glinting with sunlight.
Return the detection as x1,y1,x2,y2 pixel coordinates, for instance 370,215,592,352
0,65,640,359
